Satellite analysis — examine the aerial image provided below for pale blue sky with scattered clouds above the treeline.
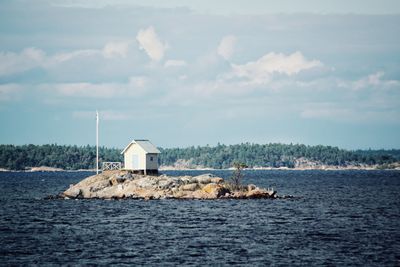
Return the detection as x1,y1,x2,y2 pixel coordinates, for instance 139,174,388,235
0,0,400,149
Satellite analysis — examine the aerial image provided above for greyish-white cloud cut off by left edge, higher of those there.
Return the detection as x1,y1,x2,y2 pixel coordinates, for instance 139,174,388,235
0,47,46,76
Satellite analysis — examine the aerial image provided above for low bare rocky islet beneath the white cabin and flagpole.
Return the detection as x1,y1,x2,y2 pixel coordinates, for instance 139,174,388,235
59,171,277,199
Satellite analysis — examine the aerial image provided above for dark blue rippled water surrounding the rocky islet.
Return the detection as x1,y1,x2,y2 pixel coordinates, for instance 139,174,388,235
0,171,400,266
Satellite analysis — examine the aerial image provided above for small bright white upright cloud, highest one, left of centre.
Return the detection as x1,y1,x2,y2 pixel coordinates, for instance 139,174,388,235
136,26,167,61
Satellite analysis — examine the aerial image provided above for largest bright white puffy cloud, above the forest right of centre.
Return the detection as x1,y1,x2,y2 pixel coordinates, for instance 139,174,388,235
227,52,323,84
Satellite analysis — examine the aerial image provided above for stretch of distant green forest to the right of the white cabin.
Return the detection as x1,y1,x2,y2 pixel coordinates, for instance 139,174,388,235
160,143,400,169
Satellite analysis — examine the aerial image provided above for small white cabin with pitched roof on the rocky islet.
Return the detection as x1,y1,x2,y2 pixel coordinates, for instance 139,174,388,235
121,139,161,174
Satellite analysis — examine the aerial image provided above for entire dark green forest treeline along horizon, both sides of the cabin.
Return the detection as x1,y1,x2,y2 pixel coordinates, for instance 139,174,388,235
0,143,400,170
